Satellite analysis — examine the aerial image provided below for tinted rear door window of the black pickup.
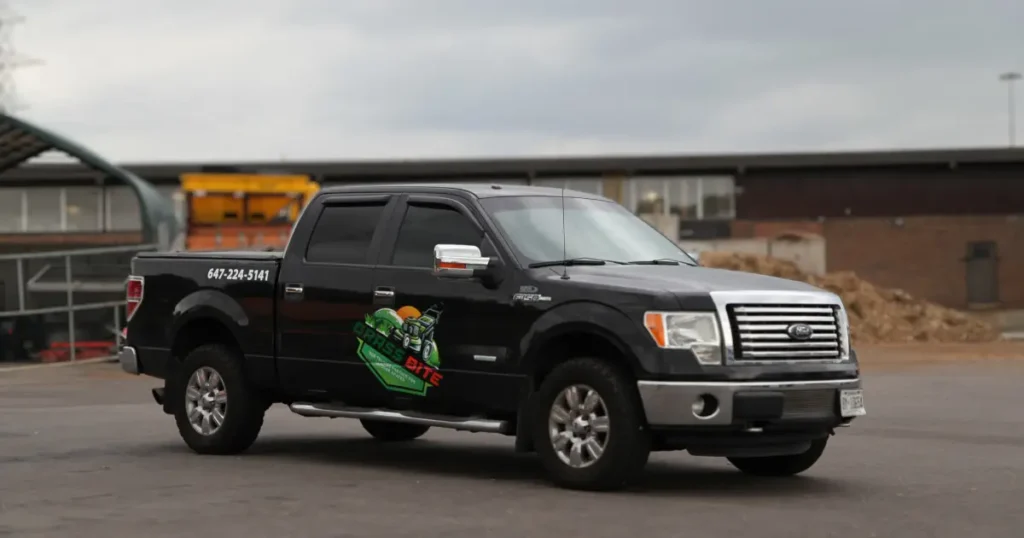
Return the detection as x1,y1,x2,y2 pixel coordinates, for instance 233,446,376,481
306,202,385,263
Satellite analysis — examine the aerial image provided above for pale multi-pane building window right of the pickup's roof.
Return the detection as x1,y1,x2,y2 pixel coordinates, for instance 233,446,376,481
626,176,735,220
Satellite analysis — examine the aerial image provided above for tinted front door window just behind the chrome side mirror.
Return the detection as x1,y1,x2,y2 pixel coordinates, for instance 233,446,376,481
391,204,482,267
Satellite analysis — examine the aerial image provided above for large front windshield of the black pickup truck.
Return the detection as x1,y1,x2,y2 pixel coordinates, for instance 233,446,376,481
480,196,697,265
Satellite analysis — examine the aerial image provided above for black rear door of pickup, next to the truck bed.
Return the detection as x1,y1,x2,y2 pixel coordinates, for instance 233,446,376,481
278,194,397,405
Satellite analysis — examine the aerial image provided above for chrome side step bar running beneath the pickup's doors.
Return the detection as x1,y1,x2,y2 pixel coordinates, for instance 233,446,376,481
289,403,511,433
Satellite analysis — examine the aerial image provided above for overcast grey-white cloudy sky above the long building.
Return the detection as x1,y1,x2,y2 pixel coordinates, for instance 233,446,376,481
8,0,1024,162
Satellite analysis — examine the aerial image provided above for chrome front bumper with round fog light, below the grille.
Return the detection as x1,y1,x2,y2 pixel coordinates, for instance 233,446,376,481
637,379,863,427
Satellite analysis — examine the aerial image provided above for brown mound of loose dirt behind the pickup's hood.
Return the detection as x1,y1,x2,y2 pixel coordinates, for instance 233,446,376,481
700,252,999,343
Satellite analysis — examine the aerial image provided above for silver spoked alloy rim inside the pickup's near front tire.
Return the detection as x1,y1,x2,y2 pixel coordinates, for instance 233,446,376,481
548,384,610,468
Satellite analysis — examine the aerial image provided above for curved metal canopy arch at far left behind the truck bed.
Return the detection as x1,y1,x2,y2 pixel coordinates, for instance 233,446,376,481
0,114,181,242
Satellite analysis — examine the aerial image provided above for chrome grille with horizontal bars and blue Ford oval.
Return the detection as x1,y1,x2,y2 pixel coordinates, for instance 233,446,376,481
727,304,843,361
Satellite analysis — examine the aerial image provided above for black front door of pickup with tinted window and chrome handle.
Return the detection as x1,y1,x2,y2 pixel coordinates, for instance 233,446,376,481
372,195,522,414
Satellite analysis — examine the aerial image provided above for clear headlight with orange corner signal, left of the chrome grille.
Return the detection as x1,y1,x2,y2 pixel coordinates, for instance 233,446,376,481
644,312,722,365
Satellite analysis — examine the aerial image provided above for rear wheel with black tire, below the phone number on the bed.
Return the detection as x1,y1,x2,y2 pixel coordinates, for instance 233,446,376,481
174,344,269,455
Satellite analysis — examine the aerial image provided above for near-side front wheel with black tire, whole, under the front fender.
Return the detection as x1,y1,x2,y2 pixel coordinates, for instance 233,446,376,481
530,359,651,491
